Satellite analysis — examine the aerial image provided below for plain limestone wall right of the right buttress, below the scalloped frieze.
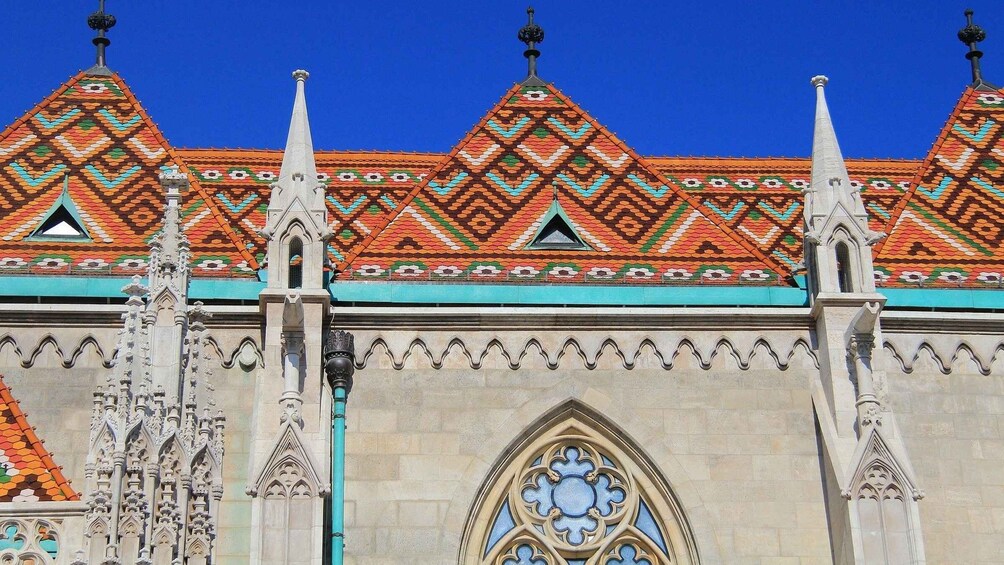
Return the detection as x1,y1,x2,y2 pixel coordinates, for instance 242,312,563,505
889,357,1004,563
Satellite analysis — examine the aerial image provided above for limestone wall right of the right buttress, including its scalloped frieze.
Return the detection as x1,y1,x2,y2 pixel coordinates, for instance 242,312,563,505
884,316,1004,563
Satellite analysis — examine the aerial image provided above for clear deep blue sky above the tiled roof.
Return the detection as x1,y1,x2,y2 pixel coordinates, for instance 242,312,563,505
0,0,1004,158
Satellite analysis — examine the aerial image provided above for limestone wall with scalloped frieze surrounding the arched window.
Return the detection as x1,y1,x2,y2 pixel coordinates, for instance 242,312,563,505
334,312,832,564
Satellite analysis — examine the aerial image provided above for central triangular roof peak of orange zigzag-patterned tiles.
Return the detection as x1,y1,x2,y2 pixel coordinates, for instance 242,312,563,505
342,85,785,284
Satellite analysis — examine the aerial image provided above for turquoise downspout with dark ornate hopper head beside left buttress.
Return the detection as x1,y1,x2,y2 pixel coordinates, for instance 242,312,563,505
324,330,355,565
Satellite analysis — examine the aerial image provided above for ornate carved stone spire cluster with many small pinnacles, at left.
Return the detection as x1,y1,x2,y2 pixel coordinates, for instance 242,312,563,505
84,170,225,565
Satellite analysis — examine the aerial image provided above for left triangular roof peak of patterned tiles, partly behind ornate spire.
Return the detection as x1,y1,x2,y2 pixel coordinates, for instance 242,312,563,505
0,73,257,277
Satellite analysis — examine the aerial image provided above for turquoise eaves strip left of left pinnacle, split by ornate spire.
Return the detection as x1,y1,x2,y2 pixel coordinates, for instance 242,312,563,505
0,275,265,300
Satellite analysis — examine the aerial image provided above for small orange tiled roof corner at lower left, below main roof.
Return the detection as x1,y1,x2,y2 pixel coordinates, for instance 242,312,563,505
0,376,79,502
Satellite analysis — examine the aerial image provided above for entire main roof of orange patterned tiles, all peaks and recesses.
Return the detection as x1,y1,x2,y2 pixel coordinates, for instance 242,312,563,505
0,73,1004,287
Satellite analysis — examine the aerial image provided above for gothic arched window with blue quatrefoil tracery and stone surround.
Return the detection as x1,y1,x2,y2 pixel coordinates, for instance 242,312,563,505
463,403,697,565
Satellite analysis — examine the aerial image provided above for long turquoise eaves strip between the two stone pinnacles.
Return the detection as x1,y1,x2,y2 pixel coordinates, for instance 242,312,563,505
330,281,808,306
